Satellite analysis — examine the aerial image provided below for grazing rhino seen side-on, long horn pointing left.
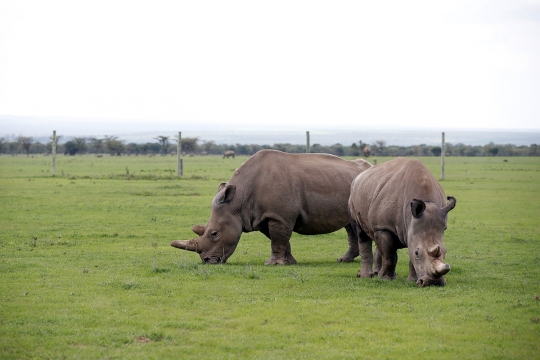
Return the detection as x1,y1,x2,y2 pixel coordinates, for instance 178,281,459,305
171,150,371,265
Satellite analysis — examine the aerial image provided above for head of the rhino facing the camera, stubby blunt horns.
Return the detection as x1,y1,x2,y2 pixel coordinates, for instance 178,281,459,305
408,196,456,287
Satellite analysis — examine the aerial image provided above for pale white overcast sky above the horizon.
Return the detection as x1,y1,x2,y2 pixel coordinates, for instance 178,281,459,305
0,0,540,133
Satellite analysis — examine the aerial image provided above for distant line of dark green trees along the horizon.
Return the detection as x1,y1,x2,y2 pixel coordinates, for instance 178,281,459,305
0,135,540,156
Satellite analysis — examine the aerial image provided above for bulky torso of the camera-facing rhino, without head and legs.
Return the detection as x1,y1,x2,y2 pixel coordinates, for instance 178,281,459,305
349,158,445,244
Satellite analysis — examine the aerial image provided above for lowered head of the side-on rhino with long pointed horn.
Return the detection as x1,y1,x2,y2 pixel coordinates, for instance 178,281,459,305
171,183,242,264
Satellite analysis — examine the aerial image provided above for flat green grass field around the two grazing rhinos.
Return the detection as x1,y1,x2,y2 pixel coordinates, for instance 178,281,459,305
0,156,540,359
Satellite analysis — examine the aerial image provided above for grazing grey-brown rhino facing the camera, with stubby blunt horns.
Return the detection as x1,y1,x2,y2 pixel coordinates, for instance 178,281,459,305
349,158,456,287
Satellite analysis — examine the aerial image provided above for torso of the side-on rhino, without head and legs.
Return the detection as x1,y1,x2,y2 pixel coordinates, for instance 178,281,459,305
229,150,371,235
